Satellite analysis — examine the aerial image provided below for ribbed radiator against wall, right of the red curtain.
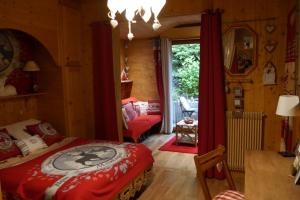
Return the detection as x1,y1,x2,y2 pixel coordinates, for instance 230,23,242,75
226,111,264,171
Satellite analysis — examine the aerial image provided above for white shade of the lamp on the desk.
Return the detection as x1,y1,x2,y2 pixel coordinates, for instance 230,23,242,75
276,95,299,116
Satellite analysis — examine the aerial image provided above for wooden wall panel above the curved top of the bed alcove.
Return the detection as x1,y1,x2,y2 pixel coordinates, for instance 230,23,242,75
0,0,58,62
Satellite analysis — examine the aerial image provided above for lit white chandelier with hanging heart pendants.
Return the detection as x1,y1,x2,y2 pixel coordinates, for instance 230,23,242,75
107,0,166,40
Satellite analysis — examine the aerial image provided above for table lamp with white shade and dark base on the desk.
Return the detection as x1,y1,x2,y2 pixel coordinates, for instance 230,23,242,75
276,95,299,157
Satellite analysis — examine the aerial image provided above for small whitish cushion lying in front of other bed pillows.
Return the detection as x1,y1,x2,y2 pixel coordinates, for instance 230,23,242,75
16,135,48,156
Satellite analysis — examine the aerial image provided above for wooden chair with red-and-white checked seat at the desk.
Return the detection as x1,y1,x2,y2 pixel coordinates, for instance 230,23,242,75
194,145,244,200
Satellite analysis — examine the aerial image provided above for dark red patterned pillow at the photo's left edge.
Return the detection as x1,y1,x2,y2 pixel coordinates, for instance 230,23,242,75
0,129,21,161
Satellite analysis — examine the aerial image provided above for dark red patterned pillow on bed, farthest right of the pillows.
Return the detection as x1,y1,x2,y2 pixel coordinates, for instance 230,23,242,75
26,122,64,146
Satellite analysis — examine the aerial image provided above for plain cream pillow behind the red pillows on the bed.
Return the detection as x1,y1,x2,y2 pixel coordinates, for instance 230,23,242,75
1,119,40,140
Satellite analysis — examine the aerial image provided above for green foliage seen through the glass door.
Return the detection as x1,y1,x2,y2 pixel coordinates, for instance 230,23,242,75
172,44,200,99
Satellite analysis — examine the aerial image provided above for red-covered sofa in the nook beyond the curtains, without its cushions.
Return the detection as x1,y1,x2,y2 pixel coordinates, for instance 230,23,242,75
122,97,162,143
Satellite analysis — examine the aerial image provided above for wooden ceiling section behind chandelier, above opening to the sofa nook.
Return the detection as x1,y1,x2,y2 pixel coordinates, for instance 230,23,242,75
119,14,201,39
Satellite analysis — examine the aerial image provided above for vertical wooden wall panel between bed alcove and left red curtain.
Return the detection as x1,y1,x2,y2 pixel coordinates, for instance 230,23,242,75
60,5,88,137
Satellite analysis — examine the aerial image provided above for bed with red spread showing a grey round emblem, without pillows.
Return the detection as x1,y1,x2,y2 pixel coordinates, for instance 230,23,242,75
0,119,153,200
